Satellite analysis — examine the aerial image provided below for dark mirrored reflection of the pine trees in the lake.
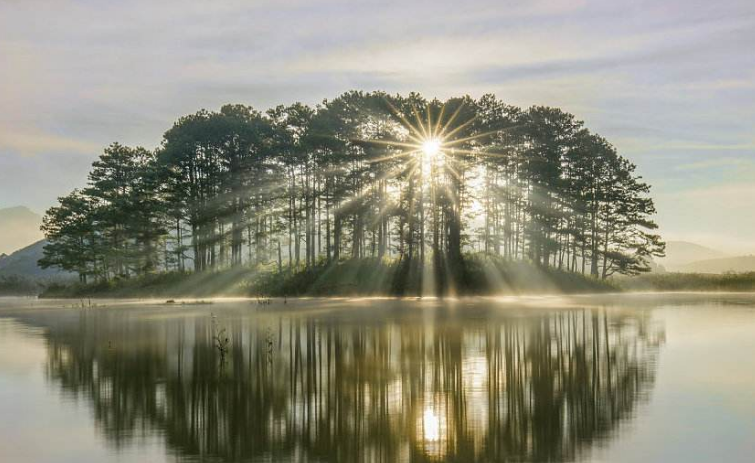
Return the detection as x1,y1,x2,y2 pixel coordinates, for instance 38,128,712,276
44,311,663,462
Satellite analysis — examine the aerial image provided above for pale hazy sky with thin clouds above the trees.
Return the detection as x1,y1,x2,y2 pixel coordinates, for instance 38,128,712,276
0,0,755,254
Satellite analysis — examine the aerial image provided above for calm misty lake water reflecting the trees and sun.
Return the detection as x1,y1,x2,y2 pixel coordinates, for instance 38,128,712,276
0,294,755,462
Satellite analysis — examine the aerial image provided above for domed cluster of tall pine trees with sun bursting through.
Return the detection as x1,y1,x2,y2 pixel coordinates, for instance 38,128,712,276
41,91,663,282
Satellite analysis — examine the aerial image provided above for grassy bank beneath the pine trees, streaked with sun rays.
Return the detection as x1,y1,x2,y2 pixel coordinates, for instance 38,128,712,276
41,254,617,298
